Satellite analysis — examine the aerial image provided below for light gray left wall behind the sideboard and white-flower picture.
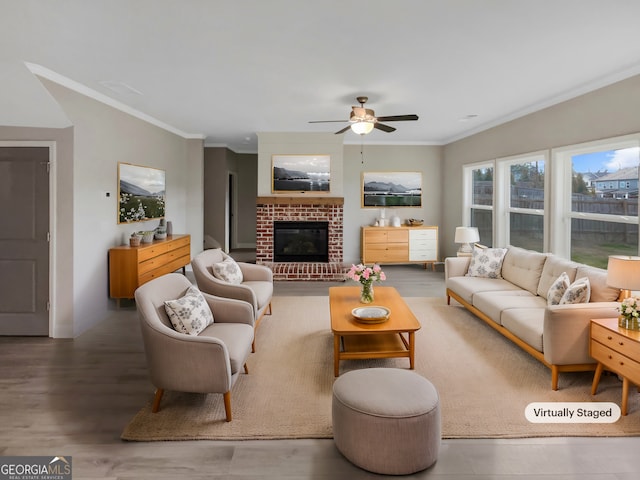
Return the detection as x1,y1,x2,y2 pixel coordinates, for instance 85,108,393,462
42,79,202,336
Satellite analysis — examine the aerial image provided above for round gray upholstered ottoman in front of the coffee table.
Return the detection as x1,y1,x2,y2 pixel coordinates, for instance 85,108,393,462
331,368,441,475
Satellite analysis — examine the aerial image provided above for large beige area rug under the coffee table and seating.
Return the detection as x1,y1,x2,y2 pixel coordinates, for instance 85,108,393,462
122,297,640,441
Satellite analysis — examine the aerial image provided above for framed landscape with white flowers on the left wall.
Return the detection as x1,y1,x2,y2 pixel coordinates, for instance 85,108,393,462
118,163,165,223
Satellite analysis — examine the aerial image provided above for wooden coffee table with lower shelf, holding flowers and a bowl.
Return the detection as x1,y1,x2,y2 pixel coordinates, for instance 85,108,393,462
329,285,420,377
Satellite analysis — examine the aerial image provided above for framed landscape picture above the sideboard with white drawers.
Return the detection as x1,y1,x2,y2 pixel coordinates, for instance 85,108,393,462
362,172,422,208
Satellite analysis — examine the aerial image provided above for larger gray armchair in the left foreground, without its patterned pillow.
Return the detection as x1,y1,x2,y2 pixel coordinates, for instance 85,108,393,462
135,273,254,422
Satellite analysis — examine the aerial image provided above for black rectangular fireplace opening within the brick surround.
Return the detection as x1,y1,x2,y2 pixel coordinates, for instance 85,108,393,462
273,222,329,262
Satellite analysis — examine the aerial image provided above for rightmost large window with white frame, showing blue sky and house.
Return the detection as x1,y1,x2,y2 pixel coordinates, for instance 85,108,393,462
554,136,640,268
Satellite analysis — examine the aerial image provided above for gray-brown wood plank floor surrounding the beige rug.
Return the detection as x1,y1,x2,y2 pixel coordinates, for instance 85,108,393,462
0,267,640,480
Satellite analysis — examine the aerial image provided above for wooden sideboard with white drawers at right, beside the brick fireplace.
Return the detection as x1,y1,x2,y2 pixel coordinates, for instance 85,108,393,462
361,225,438,266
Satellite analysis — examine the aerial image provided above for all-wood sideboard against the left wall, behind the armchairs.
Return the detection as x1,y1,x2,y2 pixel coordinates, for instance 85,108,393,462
109,235,191,304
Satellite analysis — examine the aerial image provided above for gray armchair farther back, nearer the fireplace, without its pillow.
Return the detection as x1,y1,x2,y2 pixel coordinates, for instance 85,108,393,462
191,248,273,351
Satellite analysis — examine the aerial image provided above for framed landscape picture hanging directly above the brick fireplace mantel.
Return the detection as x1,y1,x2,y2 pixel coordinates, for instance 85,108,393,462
271,155,331,193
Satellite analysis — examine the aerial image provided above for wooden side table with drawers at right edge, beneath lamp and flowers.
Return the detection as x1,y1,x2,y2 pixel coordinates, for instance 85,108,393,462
589,318,640,415
